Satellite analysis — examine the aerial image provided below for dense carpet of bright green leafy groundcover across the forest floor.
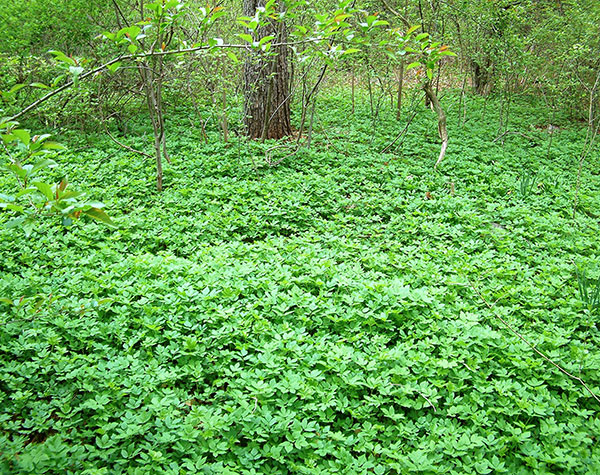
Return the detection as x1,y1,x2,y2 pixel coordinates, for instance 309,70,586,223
0,91,600,474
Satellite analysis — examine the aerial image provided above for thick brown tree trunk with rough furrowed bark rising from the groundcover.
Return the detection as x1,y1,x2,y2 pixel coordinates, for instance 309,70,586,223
244,0,292,139
